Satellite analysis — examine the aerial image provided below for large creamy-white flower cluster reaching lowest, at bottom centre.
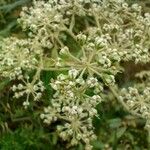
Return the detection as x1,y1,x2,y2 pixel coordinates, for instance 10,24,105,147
41,69,102,150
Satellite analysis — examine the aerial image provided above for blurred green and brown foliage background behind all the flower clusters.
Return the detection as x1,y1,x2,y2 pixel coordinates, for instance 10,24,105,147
0,0,150,150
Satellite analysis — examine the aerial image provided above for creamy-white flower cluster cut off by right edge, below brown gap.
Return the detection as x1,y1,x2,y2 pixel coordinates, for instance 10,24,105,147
119,70,150,130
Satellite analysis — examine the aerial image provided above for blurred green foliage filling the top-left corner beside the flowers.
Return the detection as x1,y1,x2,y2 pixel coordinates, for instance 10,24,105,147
0,0,32,37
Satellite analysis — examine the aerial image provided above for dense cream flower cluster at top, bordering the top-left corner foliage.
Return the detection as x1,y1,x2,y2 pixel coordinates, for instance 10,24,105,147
18,0,101,34
